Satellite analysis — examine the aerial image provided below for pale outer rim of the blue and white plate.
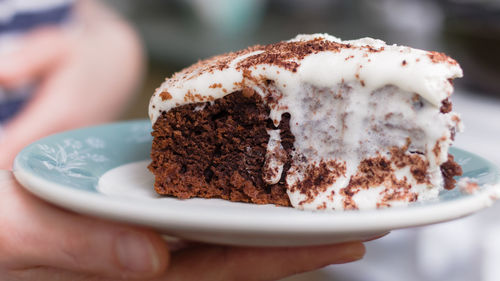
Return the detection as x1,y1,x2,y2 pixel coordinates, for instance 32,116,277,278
9,119,500,233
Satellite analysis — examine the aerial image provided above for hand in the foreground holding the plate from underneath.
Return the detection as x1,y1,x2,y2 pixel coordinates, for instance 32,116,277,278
0,171,365,281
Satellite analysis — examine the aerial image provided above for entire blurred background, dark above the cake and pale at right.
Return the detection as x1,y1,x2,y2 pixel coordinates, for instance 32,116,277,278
105,0,500,281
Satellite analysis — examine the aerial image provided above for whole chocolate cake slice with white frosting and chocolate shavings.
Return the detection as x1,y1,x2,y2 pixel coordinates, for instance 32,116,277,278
149,34,462,210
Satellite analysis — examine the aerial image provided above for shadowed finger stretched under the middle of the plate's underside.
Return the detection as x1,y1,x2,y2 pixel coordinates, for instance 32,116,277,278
162,242,365,280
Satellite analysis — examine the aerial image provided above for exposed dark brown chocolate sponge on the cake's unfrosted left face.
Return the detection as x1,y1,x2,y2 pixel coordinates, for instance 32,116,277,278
149,90,294,206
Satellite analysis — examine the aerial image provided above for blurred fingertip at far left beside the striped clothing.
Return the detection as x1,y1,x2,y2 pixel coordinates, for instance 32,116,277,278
0,27,70,88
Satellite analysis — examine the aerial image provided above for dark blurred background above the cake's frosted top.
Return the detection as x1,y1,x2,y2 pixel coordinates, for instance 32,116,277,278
104,0,500,117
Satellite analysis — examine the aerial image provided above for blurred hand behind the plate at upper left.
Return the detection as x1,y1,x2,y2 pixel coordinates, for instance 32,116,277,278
0,0,146,169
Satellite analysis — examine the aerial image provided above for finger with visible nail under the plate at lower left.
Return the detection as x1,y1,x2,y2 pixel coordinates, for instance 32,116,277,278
0,171,169,279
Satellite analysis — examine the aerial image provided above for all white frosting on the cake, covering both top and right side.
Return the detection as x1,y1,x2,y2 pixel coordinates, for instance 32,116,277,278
149,34,462,210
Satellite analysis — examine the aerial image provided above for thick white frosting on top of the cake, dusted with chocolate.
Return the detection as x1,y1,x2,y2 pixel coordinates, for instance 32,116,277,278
149,34,462,123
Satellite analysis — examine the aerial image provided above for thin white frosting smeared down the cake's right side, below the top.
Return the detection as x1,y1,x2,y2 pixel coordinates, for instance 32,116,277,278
283,84,458,210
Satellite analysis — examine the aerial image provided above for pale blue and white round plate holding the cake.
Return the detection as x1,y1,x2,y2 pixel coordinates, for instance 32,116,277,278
14,120,500,246
